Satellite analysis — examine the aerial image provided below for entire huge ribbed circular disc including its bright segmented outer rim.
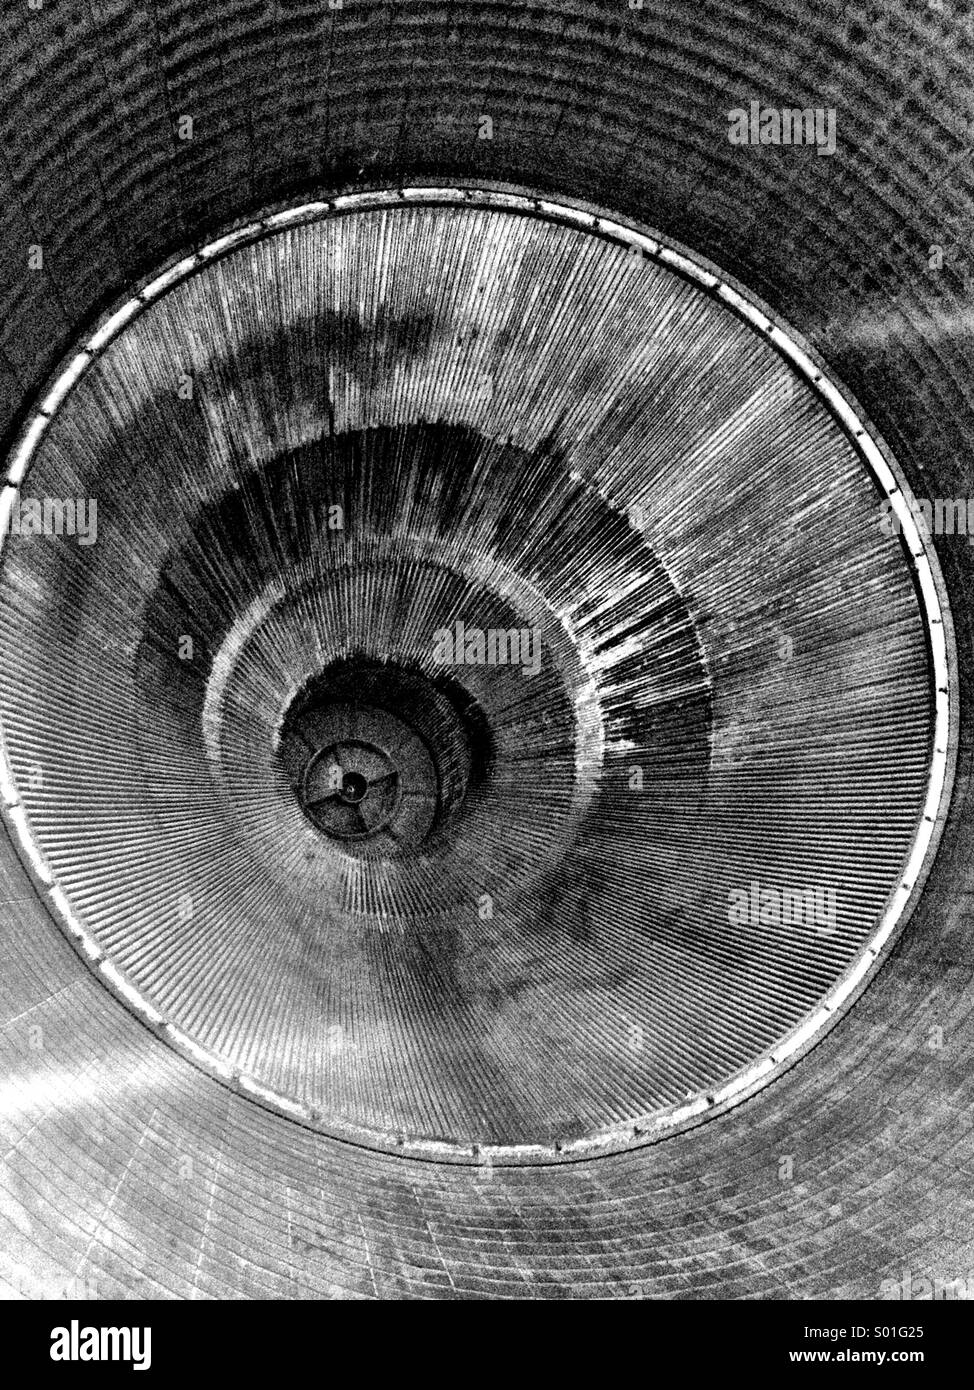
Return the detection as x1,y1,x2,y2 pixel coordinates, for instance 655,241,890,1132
0,189,950,1163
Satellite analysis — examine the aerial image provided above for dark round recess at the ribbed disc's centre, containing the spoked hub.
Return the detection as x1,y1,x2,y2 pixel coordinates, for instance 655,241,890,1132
278,657,489,858
